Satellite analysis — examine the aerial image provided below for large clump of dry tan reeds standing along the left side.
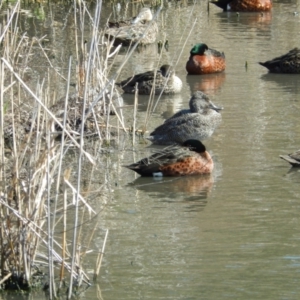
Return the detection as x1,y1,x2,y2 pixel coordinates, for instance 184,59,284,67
0,1,127,298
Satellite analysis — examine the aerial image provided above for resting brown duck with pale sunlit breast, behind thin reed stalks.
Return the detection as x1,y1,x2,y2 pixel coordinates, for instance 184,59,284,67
117,65,182,95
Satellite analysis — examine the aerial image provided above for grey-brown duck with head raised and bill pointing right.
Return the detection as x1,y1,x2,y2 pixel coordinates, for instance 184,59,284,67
147,91,223,145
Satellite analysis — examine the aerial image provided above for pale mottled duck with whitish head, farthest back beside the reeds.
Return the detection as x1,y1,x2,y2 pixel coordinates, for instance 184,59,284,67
104,7,158,46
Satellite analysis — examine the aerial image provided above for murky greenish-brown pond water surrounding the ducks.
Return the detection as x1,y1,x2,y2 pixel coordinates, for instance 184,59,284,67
2,0,300,300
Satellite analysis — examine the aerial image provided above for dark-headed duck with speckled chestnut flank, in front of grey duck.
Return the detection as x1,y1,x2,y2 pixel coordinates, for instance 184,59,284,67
124,139,214,177
